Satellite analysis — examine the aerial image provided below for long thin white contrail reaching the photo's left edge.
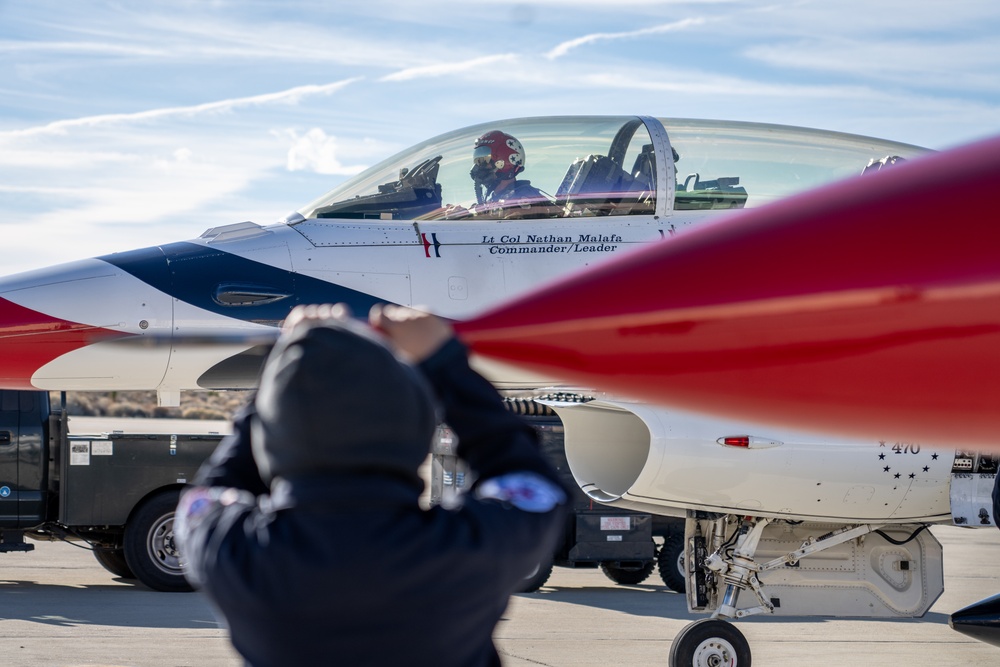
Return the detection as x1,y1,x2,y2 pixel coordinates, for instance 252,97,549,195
0,77,359,140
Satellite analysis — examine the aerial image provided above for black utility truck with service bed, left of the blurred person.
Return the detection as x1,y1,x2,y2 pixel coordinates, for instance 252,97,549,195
0,390,223,591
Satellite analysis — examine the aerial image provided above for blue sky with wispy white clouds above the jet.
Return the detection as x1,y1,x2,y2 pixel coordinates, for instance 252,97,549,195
0,0,1000,275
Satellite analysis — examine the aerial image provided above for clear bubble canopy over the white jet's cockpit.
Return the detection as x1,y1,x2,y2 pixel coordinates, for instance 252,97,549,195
290,116,924,220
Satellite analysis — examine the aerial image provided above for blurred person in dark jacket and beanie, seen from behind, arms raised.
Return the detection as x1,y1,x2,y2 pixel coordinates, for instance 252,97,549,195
176,306,567,667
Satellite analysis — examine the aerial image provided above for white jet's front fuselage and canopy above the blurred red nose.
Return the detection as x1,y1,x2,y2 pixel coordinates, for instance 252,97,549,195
0,117,924,404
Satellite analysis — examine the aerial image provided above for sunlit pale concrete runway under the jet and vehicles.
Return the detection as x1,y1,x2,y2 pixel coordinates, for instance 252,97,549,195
0,527,1000,667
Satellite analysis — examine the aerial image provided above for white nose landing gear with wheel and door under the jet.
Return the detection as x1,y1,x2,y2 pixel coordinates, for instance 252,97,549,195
670,515,932,667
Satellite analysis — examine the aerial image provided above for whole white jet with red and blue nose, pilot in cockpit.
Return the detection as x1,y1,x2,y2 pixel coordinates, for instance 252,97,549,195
0,117,996,665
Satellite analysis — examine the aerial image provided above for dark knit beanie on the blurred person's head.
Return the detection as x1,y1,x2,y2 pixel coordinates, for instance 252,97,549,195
252,321,436,483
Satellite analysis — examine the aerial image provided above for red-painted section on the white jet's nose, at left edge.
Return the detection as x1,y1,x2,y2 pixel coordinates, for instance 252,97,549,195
0,297,121,389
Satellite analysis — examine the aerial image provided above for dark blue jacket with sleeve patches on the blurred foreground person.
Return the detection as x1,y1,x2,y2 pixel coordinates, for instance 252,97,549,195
177,340,565,667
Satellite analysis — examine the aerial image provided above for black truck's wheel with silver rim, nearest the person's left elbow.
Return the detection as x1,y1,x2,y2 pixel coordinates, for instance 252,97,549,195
125,491,191,592
